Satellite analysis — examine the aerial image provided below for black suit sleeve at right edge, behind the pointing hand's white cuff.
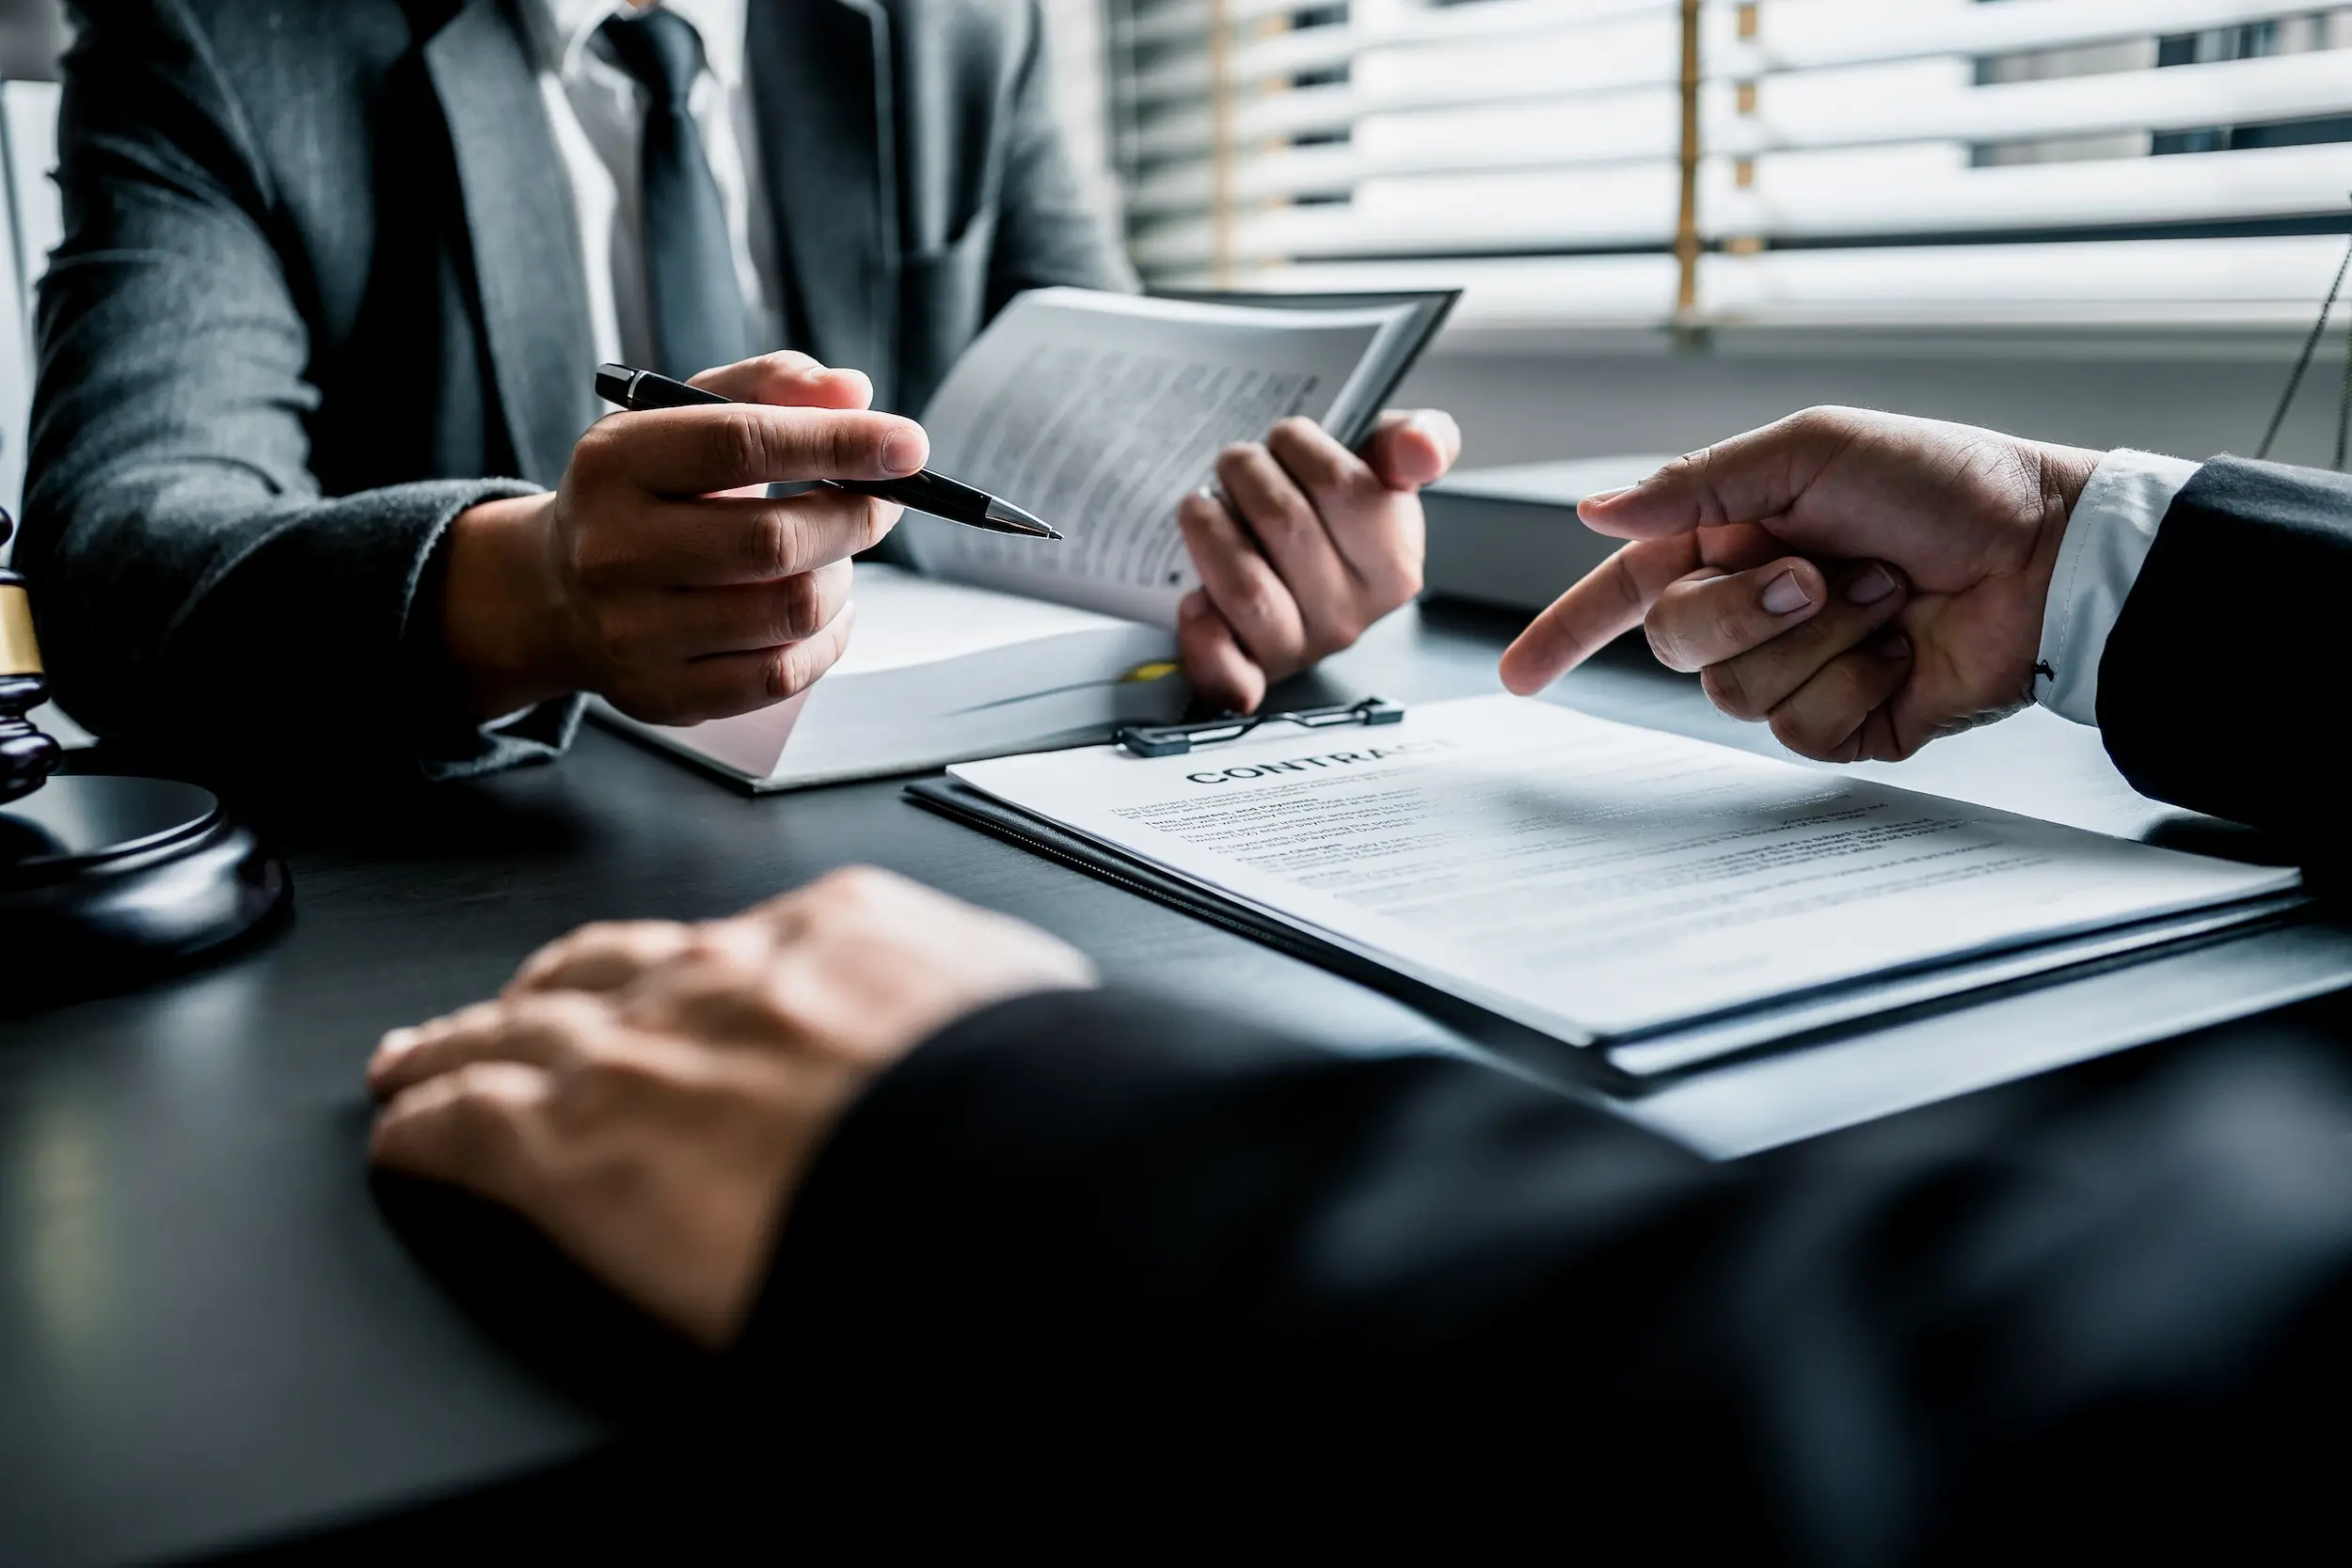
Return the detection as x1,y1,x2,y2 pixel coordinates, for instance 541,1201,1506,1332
2098,458,2352,844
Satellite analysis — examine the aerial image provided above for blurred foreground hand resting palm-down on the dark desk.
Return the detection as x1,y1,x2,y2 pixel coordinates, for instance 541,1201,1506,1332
367,870,1094,1345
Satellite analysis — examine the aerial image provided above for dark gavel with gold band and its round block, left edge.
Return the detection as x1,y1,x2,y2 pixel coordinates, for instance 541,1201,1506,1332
0,513,290,1008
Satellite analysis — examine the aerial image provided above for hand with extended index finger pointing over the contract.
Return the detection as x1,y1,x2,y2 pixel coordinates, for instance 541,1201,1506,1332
1503,409,2098,762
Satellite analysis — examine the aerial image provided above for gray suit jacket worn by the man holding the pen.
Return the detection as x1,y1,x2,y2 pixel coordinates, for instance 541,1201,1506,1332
17,0,1132,773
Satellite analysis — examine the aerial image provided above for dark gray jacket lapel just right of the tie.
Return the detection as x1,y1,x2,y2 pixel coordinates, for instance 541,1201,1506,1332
746,0,898,406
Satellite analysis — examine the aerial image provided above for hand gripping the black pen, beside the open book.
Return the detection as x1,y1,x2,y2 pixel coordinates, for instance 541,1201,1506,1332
442,353,955,724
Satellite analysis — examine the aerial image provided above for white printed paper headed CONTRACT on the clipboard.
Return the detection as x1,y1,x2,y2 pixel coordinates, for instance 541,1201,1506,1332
953,696,2300,1058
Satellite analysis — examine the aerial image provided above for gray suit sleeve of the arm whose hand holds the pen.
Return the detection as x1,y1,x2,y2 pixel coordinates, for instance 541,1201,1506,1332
17,0,569,773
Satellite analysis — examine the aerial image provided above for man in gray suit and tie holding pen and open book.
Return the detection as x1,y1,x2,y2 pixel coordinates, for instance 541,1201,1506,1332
17,0,1458,776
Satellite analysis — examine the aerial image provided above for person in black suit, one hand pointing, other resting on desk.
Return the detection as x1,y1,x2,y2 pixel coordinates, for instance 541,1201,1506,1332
372,411,2352,1563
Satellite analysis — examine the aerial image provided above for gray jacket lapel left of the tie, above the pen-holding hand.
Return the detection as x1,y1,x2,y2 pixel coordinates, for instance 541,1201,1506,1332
423,0,596,484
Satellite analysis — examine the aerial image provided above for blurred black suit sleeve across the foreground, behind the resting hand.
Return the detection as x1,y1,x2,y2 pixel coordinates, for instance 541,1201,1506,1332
732,994,2352,1563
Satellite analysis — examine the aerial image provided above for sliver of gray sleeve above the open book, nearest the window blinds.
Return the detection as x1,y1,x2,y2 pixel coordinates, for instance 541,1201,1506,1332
988,0,1138,315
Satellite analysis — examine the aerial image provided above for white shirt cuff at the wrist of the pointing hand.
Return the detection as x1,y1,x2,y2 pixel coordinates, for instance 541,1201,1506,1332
2035,449,2204,724
